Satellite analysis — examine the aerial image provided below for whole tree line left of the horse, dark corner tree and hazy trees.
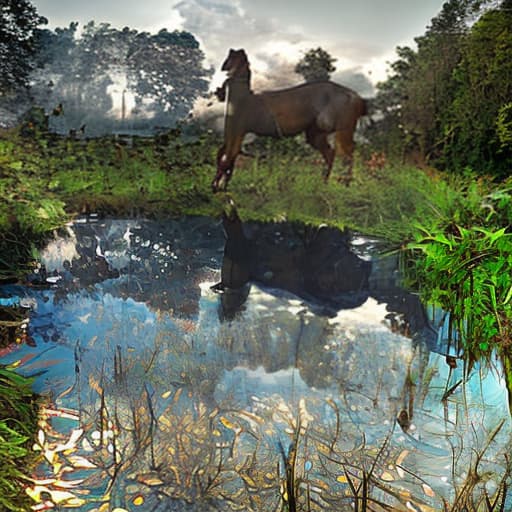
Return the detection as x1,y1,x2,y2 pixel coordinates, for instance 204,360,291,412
0,0,213,132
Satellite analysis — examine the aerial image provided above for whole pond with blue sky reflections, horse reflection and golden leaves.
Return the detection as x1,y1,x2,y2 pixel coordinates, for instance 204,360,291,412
0,215,512,512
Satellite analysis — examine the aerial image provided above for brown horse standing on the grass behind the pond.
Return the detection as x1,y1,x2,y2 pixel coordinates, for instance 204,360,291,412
212,49,366,192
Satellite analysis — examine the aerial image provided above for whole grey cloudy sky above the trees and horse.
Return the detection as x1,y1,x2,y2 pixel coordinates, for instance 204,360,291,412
32,0,443,94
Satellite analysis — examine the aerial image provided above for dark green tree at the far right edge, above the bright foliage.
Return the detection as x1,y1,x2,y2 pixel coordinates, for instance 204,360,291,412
442,2,512,175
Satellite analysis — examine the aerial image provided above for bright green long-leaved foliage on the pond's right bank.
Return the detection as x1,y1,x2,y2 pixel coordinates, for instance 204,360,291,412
408,181,512,403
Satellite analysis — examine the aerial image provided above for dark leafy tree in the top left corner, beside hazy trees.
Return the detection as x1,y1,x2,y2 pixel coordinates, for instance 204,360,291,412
0,0,48,94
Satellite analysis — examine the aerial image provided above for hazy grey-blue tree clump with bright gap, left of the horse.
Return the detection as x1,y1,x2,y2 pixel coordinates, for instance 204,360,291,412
27,22,209,135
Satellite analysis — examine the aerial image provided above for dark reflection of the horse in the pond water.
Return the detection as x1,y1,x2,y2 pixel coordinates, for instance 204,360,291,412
212,203,371,320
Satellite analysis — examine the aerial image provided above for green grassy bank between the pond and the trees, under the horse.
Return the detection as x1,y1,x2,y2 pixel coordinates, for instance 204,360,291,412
0,124,446,277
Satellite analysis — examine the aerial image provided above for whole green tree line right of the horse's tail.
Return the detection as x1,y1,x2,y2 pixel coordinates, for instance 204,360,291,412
371,0,512,178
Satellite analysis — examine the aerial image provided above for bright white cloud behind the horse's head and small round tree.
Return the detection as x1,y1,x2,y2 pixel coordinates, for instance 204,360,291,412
173,0,375,93
